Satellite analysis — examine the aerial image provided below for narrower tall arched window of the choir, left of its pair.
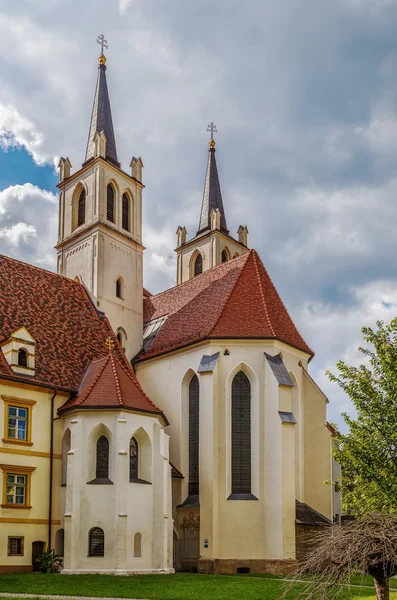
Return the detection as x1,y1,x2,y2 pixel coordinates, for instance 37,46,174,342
189,375,200,496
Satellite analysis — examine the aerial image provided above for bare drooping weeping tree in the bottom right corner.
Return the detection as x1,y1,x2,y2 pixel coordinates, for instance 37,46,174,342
284,513,397,600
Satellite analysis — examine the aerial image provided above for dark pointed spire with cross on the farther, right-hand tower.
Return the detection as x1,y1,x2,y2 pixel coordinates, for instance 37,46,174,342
197,123,229,233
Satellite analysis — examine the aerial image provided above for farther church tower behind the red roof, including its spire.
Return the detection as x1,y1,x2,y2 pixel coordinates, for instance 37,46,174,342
176,123,249,285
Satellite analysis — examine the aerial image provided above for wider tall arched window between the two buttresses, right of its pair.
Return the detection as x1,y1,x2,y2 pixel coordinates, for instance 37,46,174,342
232,371,251,494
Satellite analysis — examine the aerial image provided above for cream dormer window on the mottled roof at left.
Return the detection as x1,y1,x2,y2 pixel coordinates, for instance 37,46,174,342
1,327,36,377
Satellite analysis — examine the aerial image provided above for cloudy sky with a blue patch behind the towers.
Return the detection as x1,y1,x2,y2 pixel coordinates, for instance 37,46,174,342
0,0,397,421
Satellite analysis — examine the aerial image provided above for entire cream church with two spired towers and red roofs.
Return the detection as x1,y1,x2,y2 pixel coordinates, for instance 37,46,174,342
0,44,334,574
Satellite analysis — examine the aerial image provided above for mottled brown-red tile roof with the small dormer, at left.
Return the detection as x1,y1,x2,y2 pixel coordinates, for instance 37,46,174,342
0,255,161,420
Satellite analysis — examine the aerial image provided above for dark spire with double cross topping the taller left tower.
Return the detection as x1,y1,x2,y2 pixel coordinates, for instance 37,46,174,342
84,34,120,167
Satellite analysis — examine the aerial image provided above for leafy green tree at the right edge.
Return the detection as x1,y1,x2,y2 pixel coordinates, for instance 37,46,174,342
328,318,397,516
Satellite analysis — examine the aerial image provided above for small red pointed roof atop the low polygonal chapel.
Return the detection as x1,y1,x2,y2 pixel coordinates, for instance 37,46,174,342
60,353,165,419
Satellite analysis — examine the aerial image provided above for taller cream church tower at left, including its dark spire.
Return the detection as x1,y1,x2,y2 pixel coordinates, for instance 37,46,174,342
57,42,144,359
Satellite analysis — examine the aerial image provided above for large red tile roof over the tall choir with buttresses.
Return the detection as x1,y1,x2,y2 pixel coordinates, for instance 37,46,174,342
140,250,313,360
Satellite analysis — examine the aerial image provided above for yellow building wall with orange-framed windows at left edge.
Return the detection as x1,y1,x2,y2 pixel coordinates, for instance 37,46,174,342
0,380,68,573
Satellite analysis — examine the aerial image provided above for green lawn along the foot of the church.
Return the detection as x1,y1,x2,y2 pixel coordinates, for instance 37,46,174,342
0,573,397,600
